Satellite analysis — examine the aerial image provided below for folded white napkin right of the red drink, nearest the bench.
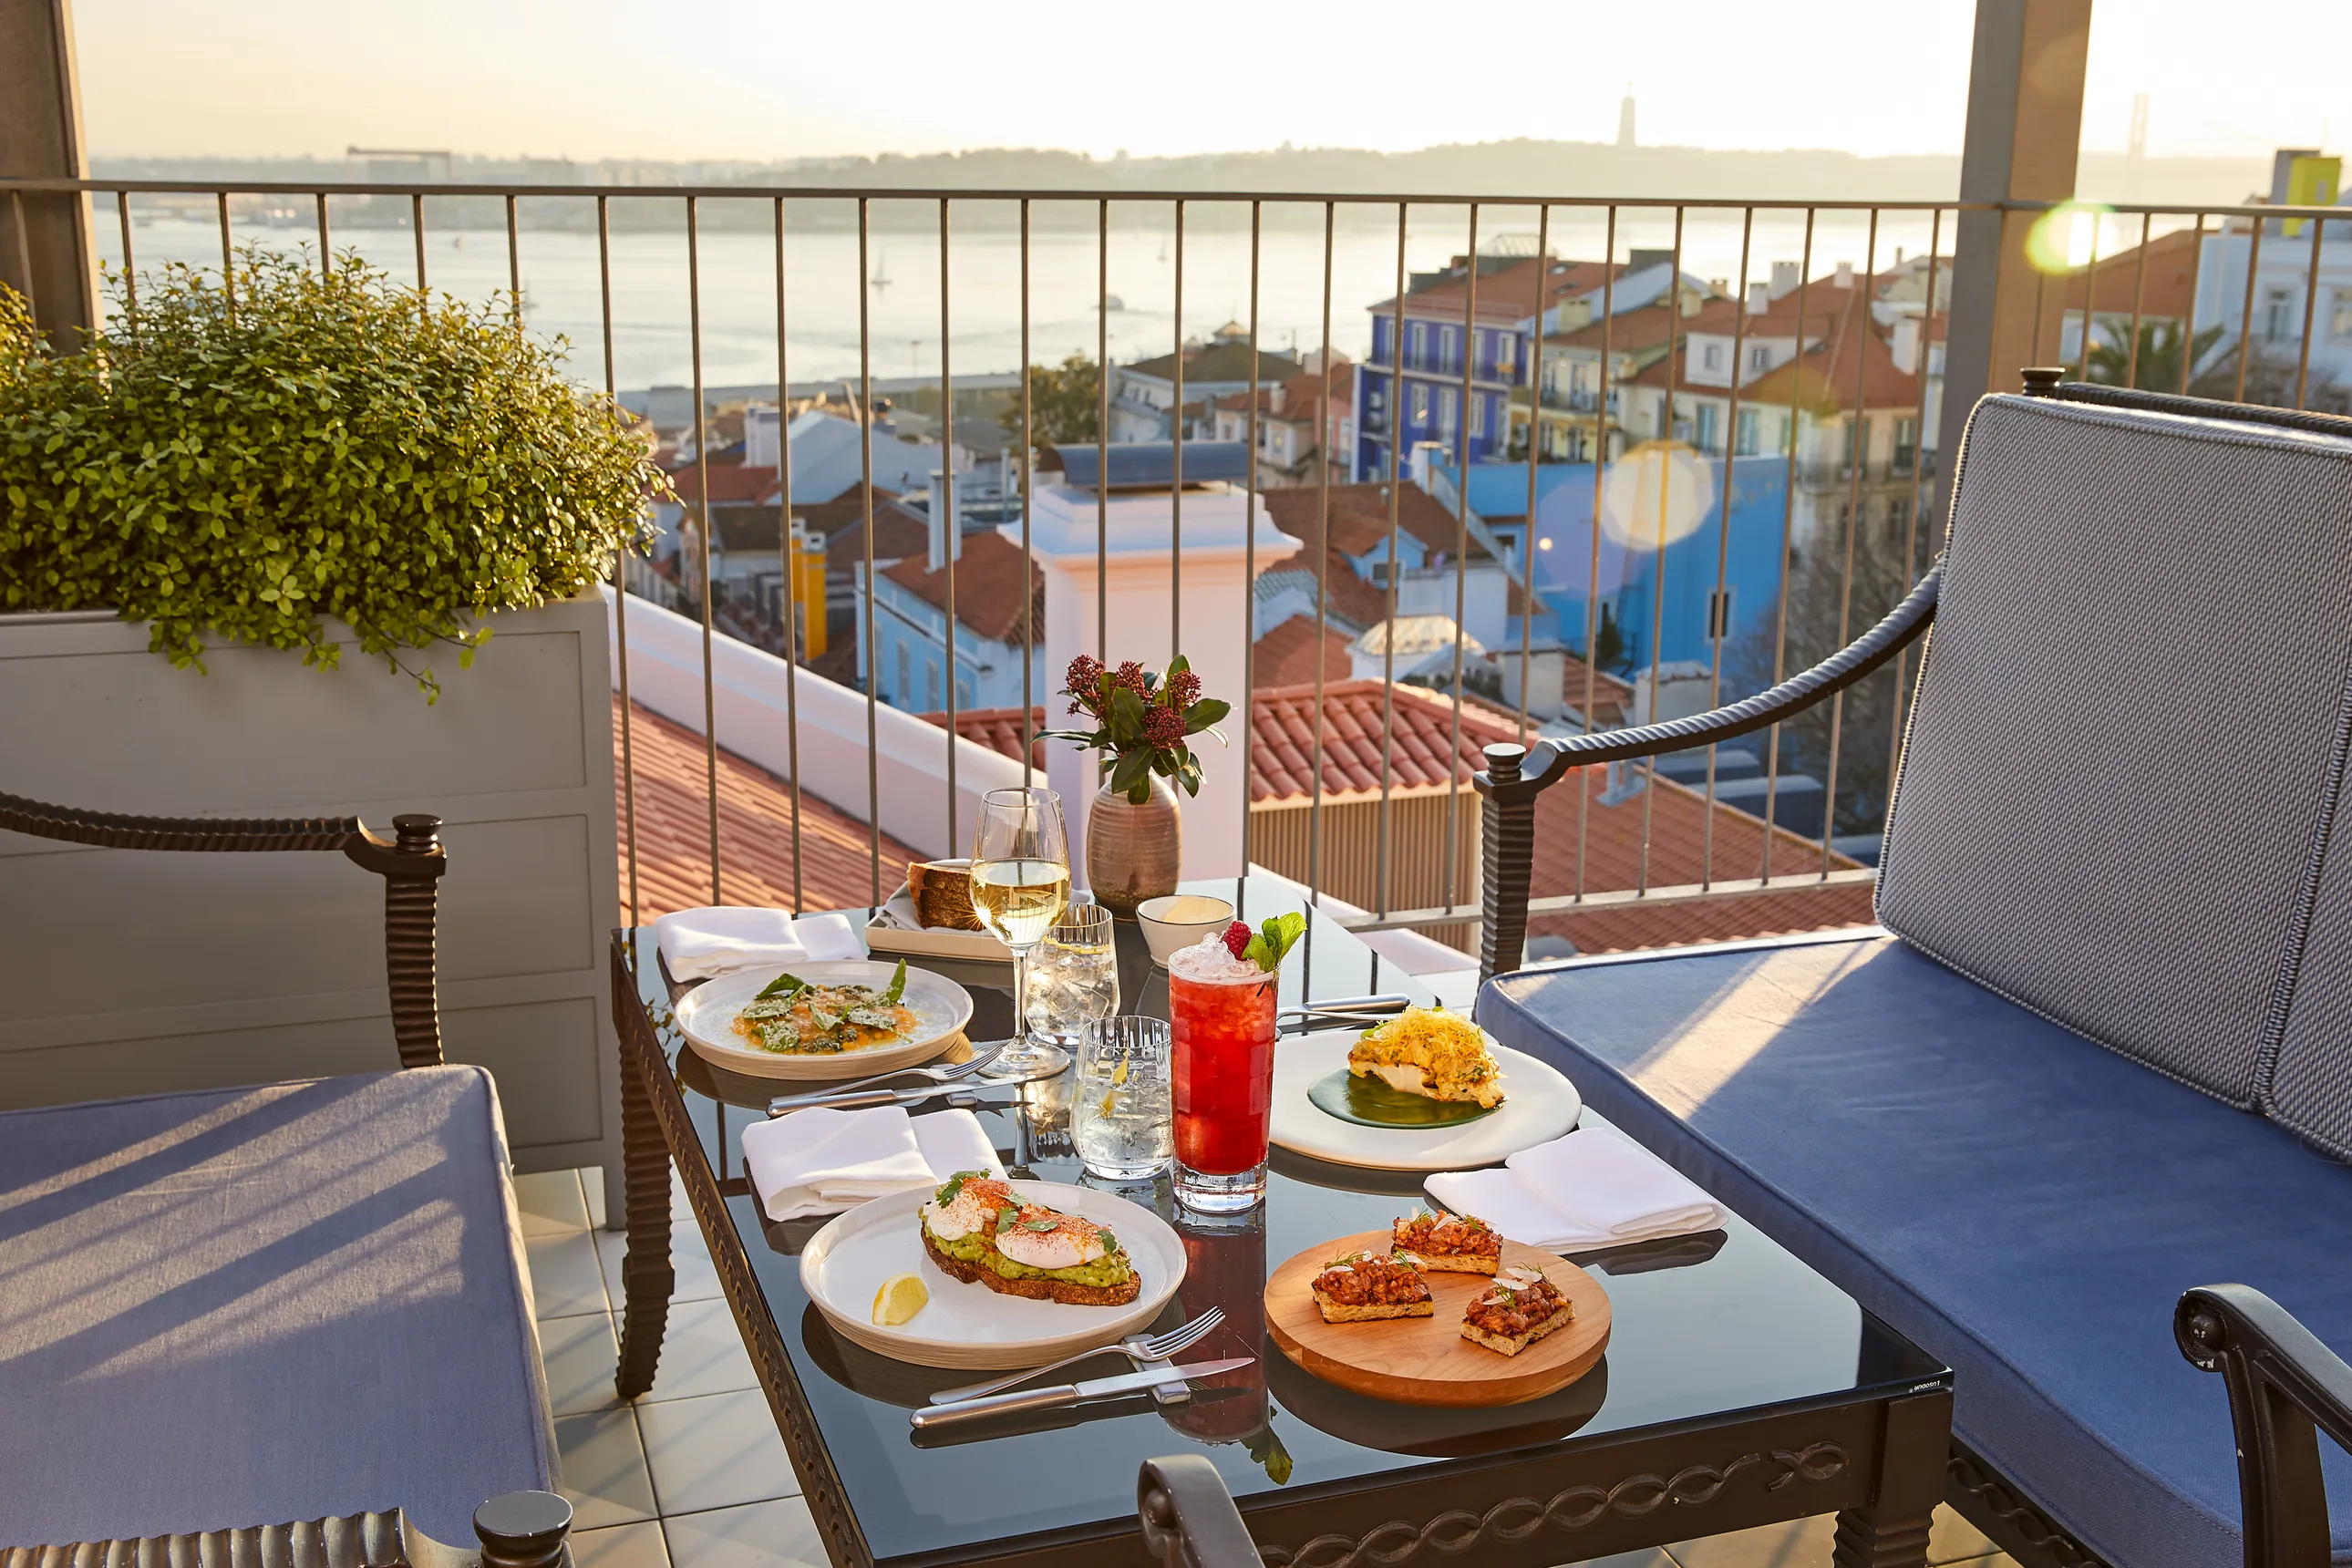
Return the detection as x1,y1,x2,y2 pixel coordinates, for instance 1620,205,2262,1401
1423,1129,1724,1253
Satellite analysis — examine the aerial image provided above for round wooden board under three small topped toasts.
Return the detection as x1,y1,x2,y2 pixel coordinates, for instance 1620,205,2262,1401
1265,1230,1609,1406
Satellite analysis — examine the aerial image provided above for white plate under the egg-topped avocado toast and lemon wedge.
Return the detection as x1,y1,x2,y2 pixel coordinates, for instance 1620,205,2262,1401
799,1182,1185,1373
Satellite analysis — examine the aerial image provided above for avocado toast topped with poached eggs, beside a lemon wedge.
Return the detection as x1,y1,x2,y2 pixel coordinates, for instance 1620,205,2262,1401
922,1171,1143,1307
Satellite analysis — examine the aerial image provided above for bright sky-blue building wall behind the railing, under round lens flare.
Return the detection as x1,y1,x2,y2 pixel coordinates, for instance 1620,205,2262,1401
1442,456,1788,703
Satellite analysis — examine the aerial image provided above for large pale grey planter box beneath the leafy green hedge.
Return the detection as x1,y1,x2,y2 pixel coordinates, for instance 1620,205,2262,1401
0,594,621,1215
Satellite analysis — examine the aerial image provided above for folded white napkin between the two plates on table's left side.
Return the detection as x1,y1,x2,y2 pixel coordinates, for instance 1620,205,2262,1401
743,1105,1005,1220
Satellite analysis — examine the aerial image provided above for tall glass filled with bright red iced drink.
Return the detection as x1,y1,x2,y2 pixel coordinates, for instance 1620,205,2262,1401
1169,938,1274,1213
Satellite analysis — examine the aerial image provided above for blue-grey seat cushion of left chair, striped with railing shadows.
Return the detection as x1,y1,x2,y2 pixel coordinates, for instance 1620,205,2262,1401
0,1068,557,1547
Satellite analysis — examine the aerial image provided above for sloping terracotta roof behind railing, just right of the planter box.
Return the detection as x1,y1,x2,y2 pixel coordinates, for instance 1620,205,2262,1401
612,696,913,923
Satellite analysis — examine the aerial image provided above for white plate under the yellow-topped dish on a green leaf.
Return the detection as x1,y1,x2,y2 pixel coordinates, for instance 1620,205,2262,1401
1270,1032,1585,1171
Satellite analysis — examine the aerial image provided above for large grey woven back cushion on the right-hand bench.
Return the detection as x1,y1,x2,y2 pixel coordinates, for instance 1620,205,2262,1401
1877,397,2352,1109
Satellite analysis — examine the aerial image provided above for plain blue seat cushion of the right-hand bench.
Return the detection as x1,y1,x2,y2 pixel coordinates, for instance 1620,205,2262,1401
1477,934,2352,1568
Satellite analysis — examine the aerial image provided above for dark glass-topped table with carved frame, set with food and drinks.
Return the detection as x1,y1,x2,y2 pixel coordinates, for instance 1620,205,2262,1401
614,879,1950,1568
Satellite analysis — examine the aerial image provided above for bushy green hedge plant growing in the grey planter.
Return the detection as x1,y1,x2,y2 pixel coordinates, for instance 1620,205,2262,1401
0,247,665,700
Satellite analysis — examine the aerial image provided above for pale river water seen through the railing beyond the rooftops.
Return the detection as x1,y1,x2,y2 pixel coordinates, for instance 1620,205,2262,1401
97,198,1952,390
